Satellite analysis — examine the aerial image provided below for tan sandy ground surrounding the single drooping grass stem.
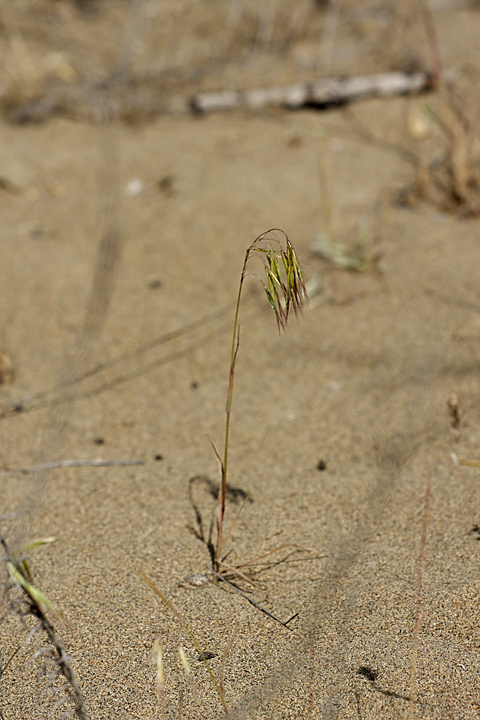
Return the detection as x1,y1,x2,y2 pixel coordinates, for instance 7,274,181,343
0,0,480,720
